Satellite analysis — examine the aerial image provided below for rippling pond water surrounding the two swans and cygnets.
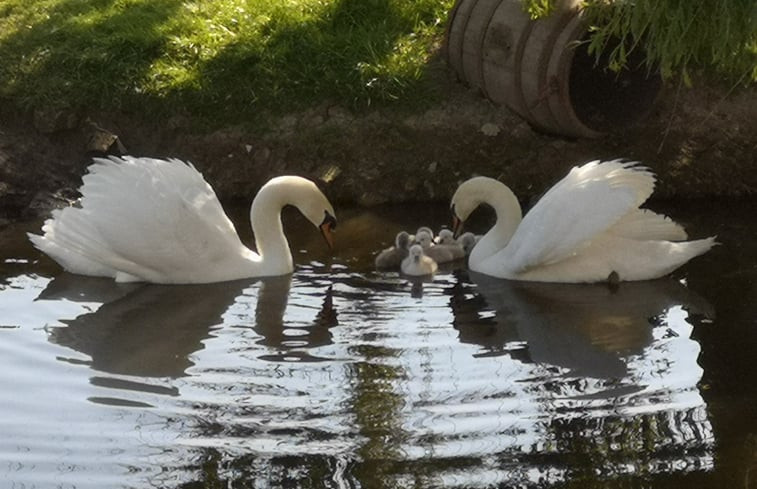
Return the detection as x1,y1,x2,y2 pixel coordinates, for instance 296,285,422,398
0,203,757,489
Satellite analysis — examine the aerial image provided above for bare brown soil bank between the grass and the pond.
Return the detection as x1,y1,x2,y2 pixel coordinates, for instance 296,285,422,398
0,65,757,224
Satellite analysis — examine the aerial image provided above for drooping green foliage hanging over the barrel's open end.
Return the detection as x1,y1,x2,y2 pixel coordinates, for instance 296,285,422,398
524,0,757,85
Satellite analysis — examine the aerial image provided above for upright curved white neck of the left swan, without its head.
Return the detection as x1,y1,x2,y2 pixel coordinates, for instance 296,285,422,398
250,187,294,275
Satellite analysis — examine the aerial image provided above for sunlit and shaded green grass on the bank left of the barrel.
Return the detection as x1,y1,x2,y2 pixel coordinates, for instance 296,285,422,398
0,0,453,127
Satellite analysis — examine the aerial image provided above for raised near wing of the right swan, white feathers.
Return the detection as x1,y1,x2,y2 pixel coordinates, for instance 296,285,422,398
498,160,655,273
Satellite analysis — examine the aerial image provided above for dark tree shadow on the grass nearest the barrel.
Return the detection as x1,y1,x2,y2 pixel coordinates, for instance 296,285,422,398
148,0,446,123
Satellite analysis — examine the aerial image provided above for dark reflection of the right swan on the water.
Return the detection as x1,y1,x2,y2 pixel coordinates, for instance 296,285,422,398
452,272,714,379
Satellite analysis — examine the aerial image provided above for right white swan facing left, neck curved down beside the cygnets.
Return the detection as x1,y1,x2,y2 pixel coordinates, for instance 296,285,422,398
451,160,716,283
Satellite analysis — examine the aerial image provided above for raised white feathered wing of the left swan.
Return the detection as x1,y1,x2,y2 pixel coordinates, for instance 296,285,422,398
81,157,248,279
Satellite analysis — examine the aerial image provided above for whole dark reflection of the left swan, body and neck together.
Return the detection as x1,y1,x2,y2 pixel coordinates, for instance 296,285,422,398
45,274,337,377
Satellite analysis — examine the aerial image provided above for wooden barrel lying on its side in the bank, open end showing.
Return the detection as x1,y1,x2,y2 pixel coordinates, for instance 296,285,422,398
444,0,661,137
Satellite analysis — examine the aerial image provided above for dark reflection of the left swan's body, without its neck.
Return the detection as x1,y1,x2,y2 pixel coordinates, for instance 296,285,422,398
47,274,245,377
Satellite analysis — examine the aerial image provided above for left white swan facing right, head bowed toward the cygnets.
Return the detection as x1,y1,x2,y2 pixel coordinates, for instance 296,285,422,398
28,156,336,284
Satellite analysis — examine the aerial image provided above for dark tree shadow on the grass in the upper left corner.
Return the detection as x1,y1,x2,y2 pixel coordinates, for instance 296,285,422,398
0,0,182,114
